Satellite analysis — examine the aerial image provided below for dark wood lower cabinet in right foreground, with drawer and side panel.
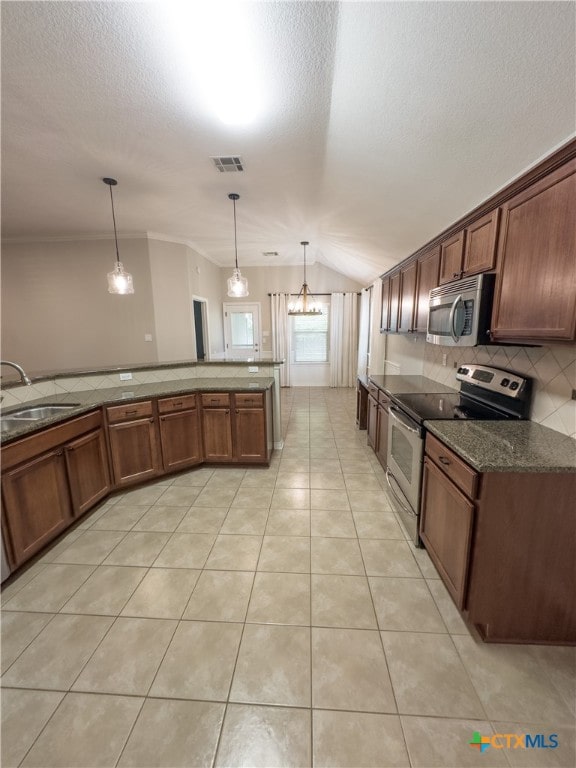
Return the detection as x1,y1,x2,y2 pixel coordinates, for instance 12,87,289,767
420,434,576,645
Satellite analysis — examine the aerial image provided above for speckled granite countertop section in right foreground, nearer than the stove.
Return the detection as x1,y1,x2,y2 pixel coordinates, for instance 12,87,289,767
424,420,576,472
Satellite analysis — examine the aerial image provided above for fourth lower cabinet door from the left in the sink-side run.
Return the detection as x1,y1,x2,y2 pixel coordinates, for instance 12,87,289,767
160,408,202,472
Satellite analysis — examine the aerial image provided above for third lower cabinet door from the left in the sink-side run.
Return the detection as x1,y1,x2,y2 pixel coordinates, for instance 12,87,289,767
108,418,160,486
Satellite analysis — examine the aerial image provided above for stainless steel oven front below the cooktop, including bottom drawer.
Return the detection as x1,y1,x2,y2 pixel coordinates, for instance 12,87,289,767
386,405,424,546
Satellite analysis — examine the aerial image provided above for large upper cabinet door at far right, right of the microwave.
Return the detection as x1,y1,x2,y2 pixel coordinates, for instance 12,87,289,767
492,160,576,341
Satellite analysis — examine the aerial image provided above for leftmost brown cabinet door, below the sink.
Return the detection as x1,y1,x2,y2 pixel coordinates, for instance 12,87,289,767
2,448,72,568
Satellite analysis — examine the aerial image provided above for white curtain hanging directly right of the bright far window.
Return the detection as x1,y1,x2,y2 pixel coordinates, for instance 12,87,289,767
330,293,358,387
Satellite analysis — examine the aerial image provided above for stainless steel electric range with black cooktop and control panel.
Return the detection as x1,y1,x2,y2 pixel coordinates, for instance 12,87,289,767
386,364,532,546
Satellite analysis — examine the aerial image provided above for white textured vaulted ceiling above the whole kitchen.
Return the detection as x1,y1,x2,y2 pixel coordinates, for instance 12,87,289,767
2,0,576,283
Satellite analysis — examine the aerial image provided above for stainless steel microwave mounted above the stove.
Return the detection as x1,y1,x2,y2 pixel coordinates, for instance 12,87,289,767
426,273,495,347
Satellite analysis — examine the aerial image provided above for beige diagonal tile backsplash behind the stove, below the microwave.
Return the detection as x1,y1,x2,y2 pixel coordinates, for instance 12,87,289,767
422,344,576,438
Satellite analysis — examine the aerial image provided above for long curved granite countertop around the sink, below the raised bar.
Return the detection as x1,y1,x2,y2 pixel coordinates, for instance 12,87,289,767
0,377,274,445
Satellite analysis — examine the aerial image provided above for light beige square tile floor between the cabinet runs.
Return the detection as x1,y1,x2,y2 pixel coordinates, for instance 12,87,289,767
1,389,576,768
